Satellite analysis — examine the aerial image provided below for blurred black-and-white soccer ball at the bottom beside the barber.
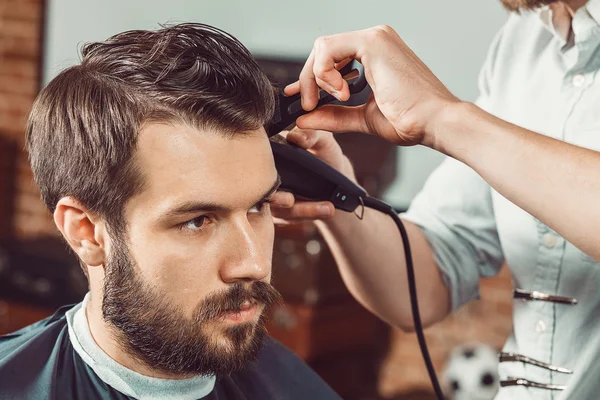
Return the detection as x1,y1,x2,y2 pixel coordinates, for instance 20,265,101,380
442,344,500,400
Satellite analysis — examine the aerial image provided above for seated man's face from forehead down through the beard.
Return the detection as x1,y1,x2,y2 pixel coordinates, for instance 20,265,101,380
103,123,279,374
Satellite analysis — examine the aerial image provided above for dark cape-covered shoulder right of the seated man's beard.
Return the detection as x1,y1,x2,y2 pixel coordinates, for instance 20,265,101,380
220,337,340,400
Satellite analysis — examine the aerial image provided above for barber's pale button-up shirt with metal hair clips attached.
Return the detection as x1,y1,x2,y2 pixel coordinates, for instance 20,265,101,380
403,0,600,400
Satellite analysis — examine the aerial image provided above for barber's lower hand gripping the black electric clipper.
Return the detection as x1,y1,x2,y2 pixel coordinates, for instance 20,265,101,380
271,128,356,225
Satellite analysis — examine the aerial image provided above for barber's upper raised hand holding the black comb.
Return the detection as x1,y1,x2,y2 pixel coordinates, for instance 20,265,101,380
285,26,459,147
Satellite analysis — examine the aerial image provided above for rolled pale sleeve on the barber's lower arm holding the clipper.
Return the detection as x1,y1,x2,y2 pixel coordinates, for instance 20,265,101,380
401,22,504,311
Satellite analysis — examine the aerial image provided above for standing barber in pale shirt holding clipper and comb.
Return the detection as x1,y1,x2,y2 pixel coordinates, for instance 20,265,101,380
273,0,600,400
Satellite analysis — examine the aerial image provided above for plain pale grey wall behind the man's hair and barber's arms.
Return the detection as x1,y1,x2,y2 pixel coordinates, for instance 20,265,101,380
44,0,506,206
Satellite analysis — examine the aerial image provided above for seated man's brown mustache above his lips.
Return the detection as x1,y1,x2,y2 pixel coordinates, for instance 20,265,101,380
195,281,283,322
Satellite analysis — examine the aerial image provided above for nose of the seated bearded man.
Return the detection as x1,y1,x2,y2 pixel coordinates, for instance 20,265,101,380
220,218,271,283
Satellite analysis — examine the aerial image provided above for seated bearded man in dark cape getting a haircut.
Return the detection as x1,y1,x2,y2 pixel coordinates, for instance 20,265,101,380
0,24,338,400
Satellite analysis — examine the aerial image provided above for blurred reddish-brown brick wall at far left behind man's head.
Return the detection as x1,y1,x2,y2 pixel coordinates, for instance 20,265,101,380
0,0,56,239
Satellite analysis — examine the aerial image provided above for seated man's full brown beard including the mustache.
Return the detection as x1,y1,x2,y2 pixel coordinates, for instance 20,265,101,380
102,236,281,376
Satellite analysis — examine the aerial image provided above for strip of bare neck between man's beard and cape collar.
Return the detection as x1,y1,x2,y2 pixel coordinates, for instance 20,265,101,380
85,296,191,380
